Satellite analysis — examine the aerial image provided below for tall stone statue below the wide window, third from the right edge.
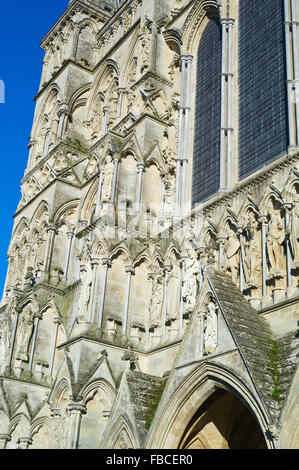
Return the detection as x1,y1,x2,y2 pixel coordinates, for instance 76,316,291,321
243,211,262,289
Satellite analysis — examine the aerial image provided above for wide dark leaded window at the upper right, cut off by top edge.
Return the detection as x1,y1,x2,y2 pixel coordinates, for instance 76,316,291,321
239,0,288,179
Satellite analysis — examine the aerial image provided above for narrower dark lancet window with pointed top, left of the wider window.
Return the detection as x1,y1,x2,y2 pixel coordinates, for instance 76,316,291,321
192,18,222,205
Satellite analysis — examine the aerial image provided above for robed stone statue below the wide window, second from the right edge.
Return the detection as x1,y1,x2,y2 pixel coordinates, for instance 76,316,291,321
267,211,285,271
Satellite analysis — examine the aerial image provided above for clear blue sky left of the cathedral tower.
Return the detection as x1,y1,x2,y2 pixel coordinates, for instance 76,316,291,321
0,0,69,297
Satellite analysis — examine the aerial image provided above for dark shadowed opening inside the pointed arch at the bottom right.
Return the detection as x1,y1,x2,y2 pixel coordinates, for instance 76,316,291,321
179,389,267,449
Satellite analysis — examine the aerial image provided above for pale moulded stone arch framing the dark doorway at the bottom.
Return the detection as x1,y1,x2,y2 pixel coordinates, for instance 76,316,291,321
145,362,274,449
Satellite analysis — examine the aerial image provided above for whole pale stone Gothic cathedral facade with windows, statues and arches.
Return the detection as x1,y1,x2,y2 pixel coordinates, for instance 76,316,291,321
0,0,299,449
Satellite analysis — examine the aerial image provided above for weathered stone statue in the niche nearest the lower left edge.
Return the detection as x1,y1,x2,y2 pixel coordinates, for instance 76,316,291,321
16,305,34,362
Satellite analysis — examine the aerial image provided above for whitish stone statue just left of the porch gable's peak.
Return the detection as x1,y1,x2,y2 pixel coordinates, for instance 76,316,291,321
183,248,200,313
